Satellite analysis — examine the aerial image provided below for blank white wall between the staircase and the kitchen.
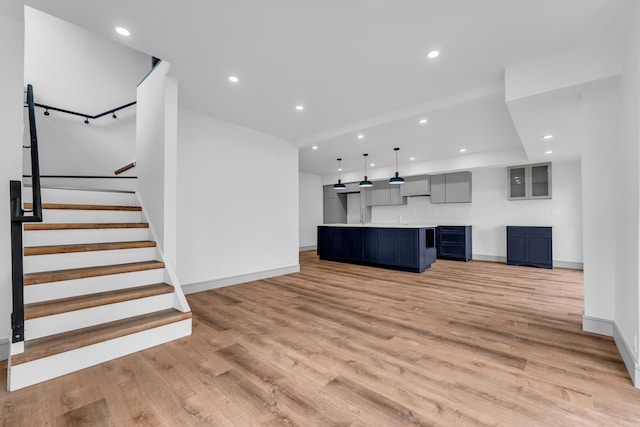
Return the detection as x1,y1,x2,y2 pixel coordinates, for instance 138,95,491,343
177,108,299,292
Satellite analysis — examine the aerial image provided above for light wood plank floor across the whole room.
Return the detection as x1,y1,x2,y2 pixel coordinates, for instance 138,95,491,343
0,252,640,427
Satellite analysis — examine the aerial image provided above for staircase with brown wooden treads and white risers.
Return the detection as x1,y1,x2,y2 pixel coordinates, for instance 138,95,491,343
7,189,191,390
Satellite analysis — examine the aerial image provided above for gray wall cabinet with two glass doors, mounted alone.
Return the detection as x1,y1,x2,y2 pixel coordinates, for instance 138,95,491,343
507,163,551,200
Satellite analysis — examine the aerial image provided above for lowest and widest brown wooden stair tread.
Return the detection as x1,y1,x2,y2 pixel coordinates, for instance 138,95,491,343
11,308,191,366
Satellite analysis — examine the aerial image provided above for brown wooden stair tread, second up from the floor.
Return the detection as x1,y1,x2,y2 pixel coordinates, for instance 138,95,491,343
24,283,173,320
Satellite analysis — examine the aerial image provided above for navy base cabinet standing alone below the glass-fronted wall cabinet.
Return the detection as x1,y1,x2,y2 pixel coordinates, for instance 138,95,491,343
507,225,553,268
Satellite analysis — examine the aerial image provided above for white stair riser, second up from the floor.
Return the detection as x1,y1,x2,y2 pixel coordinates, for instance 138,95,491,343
24,294,173,341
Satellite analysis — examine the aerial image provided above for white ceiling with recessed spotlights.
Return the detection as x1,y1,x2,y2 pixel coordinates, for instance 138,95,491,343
17,0,633,179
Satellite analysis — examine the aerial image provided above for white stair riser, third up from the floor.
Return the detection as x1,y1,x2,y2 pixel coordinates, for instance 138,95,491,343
24,268,165,304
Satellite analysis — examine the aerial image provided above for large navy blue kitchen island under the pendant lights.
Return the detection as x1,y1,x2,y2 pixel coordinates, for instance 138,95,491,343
318,224,436,273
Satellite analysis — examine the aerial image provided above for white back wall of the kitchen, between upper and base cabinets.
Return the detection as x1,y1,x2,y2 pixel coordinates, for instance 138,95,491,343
372,160,582,266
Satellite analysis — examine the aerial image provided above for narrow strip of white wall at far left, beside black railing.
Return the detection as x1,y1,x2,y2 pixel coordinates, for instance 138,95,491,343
0,10,24,359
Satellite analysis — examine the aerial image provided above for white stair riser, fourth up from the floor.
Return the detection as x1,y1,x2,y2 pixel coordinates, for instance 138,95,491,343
24,247,156,273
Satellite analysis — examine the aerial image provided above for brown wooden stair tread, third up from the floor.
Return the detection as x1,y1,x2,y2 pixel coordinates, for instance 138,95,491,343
24,261,164,286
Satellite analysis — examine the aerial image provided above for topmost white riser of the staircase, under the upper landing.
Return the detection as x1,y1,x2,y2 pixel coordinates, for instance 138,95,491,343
22,187,136,206
